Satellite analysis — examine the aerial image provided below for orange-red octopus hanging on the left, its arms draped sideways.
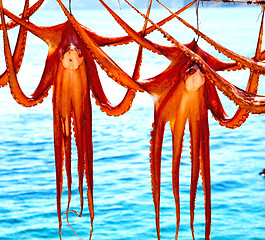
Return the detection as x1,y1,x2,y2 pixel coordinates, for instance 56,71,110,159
0,1,155,238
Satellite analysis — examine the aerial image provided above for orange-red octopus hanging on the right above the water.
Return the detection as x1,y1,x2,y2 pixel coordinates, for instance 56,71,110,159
100,0,263,239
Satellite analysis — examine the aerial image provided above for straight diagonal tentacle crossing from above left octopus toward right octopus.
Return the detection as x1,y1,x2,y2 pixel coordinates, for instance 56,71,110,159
57,0,142,91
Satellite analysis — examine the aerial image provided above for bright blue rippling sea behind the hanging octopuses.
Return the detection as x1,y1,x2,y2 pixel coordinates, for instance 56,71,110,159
0,3,265,240
